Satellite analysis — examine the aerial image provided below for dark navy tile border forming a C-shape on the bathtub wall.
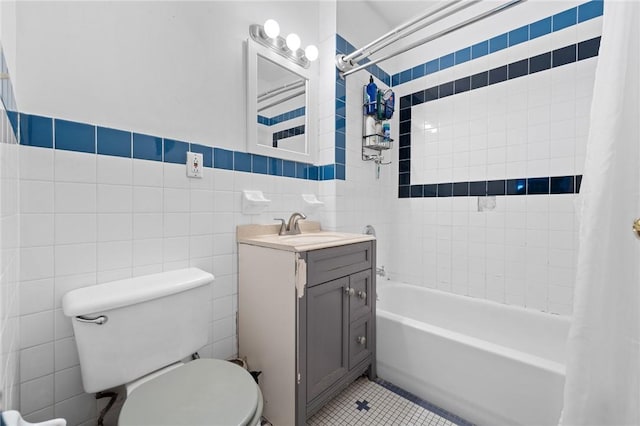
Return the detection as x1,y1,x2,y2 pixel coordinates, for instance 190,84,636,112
398,37,601,198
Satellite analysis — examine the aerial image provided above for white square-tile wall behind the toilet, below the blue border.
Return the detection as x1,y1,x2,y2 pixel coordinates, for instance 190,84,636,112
19,147,318,424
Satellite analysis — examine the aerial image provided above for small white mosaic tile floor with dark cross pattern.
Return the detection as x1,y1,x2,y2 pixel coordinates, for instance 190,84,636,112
307,377,470,426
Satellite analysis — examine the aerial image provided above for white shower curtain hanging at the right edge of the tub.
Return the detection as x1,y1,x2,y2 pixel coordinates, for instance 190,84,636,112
560,0,640,426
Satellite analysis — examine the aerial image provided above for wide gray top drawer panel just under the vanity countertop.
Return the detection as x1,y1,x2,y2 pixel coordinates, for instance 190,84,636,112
307,241,373,287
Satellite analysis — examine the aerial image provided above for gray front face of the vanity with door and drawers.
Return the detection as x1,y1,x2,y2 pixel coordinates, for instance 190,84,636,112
298,241,375,422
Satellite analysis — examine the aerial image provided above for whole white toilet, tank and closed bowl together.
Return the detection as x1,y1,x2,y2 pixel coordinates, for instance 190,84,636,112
62,268,262,426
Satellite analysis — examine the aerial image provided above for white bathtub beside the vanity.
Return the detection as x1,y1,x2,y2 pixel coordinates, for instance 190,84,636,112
376,280,569,426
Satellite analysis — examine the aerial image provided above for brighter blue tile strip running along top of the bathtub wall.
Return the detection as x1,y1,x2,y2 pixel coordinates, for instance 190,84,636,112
388,0,603,87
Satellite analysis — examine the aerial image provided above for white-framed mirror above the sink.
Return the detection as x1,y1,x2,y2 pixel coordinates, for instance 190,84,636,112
247,39,316,163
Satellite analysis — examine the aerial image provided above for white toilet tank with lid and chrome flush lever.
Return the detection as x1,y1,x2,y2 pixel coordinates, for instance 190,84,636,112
62,268,213,393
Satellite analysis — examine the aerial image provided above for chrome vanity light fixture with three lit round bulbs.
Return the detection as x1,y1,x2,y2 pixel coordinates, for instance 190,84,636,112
249,19,318,68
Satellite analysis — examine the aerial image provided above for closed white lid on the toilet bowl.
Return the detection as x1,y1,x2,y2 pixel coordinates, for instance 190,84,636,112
118,359,259,426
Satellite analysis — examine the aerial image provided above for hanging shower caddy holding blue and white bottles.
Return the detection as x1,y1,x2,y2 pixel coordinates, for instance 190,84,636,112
362,77,395,177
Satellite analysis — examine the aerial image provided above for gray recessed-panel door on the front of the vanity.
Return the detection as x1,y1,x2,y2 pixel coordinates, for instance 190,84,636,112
306,277,349,401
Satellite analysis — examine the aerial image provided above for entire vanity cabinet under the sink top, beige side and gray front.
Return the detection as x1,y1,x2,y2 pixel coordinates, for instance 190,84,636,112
238,238,376,426
